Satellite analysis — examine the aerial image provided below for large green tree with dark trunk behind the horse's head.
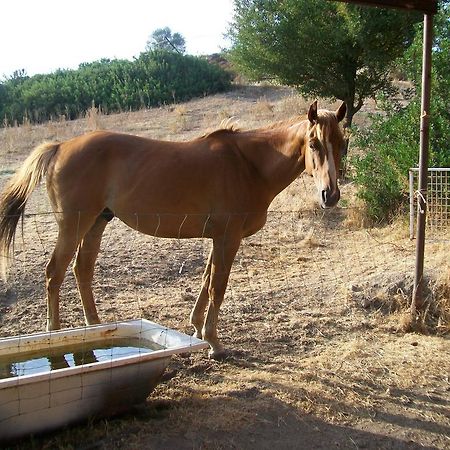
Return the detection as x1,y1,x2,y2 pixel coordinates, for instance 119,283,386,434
229,0,420,127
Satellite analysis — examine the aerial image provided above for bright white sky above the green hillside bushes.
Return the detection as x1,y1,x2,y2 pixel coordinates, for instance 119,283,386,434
0,0,233,79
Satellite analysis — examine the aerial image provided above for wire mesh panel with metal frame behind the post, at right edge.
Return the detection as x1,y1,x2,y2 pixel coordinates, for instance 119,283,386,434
409,168,450,239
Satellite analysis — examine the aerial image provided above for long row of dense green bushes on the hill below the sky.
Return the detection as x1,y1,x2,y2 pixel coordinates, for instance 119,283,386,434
0,50,231,123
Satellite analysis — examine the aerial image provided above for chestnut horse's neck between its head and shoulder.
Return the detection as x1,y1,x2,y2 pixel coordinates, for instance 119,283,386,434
239,129,305,197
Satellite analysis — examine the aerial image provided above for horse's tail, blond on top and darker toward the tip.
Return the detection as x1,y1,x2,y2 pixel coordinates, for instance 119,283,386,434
0,142,59,279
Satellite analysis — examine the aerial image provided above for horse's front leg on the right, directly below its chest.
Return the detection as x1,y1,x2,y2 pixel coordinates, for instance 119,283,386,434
202,237,241,359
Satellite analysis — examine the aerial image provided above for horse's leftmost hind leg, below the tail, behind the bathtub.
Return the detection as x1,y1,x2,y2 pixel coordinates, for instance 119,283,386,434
45,214,96,331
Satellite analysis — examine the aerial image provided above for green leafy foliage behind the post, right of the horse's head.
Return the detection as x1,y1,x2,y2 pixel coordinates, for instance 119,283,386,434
353,2,450,221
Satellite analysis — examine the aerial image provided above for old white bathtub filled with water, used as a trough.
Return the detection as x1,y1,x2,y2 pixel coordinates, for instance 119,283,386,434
0,319,208,441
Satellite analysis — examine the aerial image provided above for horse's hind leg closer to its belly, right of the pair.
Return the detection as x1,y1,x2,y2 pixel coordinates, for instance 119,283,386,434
73,216,108,325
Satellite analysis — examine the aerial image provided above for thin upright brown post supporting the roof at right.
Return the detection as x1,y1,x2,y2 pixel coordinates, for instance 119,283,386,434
411,14,433,328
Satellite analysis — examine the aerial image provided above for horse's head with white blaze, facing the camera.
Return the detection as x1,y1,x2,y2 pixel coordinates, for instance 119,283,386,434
305,101,347,208
